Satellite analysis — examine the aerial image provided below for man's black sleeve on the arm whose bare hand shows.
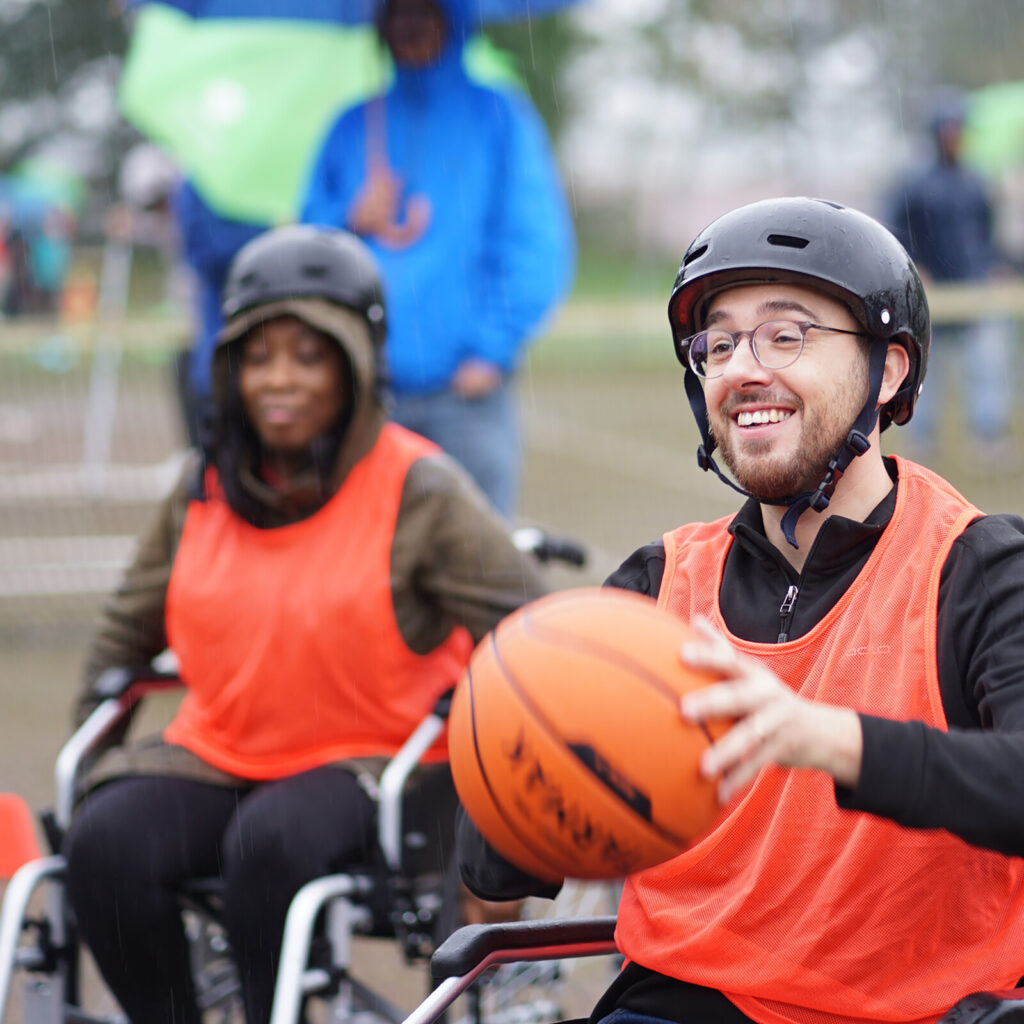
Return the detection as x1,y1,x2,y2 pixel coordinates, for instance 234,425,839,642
837,515,1024,856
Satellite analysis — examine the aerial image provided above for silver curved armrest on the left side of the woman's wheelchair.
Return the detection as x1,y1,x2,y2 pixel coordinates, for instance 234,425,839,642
54,666,182,830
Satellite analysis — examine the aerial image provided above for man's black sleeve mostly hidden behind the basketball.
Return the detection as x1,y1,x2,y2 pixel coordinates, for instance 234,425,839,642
456,542,665,900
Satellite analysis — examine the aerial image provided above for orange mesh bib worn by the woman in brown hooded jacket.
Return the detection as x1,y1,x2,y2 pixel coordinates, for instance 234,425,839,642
164,424,472,779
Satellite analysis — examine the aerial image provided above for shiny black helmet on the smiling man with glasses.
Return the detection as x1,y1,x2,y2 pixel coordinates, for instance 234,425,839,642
669,197,931,430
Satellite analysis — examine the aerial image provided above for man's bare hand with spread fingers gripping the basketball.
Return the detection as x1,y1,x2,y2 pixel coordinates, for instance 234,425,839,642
681,616,863,804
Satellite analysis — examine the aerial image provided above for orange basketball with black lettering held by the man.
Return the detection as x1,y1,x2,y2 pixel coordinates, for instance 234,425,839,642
449,588,728,880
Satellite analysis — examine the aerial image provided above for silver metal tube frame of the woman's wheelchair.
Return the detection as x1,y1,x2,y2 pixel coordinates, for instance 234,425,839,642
0,668,454,1024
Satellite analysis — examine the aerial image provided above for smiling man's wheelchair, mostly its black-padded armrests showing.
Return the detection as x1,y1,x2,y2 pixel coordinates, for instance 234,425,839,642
403,915,1024,1024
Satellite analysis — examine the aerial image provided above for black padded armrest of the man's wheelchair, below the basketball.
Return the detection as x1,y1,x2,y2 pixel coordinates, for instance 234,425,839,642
430,916,615,982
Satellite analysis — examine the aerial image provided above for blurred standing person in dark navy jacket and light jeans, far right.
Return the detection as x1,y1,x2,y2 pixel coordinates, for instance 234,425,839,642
888,91,1013,460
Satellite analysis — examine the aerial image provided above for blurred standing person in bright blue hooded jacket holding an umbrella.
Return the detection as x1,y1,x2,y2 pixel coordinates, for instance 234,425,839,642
302,0,575,516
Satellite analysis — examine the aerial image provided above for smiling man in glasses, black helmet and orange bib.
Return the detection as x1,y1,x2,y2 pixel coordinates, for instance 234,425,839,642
460,198,1024,1024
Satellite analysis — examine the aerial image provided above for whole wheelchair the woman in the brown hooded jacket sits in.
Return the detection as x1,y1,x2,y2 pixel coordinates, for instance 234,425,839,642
0,667,471,1024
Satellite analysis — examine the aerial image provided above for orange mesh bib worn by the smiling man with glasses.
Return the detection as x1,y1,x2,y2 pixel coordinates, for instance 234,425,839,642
616,461,1024,1024
